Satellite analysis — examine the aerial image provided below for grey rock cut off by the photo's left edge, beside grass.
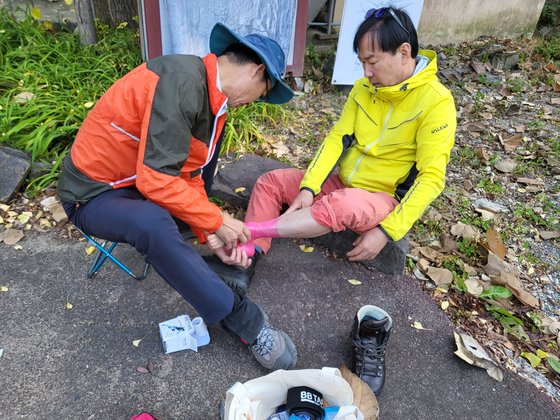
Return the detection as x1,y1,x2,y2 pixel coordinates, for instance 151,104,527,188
0,147,31,203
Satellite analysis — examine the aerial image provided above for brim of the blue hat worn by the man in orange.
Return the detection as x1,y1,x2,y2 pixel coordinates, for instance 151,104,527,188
210,23,294,104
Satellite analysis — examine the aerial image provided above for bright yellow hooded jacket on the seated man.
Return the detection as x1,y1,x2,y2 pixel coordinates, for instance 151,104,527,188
300,50,457,241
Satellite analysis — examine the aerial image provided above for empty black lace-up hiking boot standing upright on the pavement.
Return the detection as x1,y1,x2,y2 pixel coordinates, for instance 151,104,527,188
350,305,393,396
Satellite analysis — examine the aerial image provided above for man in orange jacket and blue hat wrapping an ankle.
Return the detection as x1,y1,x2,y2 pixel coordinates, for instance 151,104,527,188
57,23,297,370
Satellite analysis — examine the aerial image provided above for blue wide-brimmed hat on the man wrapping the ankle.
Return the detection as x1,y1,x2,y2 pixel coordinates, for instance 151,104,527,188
210,23,294,104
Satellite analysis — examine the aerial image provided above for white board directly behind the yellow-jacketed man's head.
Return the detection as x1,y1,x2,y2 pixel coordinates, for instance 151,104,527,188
332,0,424,85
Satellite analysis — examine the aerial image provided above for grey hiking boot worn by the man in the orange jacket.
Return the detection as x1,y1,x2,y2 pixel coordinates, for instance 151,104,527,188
249,321,297,370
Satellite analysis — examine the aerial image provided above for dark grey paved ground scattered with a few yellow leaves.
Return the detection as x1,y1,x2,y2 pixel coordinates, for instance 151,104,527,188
0,233,560,420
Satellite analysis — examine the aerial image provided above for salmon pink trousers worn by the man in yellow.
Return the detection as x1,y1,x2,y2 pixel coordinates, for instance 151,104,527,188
245,168,398,253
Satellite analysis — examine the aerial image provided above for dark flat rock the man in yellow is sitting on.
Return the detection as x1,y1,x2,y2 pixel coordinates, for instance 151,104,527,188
212,155,408,275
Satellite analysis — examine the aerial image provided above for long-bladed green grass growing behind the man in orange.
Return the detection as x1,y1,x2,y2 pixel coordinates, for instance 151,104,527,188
0,8,286,196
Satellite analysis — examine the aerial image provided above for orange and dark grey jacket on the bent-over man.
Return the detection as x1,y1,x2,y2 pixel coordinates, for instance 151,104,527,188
57,54,227,240
